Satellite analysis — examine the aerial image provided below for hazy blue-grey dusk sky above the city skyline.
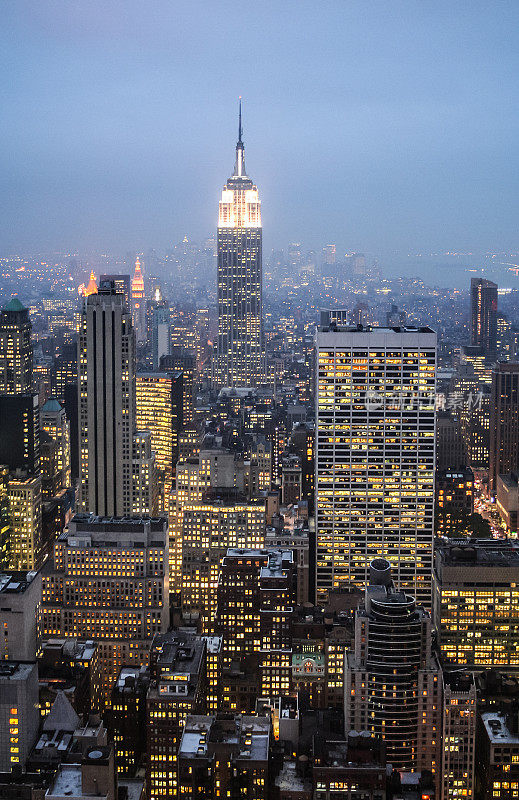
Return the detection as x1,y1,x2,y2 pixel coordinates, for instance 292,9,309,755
0,0,519,254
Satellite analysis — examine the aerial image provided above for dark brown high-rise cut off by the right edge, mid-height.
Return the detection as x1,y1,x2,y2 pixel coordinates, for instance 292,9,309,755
488,361,519,496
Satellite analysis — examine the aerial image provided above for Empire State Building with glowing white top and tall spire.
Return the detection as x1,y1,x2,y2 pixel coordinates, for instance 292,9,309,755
215,103,265,386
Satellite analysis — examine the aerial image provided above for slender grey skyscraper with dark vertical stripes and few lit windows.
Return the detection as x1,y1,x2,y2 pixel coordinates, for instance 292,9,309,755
78,284,135,516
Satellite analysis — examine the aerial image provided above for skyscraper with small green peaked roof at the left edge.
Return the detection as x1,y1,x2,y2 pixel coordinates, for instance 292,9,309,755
0,297,32,394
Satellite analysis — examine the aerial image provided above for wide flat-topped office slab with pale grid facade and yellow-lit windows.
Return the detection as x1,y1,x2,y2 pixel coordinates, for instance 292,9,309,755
316,325,436,608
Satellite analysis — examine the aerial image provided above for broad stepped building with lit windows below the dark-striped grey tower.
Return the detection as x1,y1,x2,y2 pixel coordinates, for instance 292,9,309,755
41,514,169,702
